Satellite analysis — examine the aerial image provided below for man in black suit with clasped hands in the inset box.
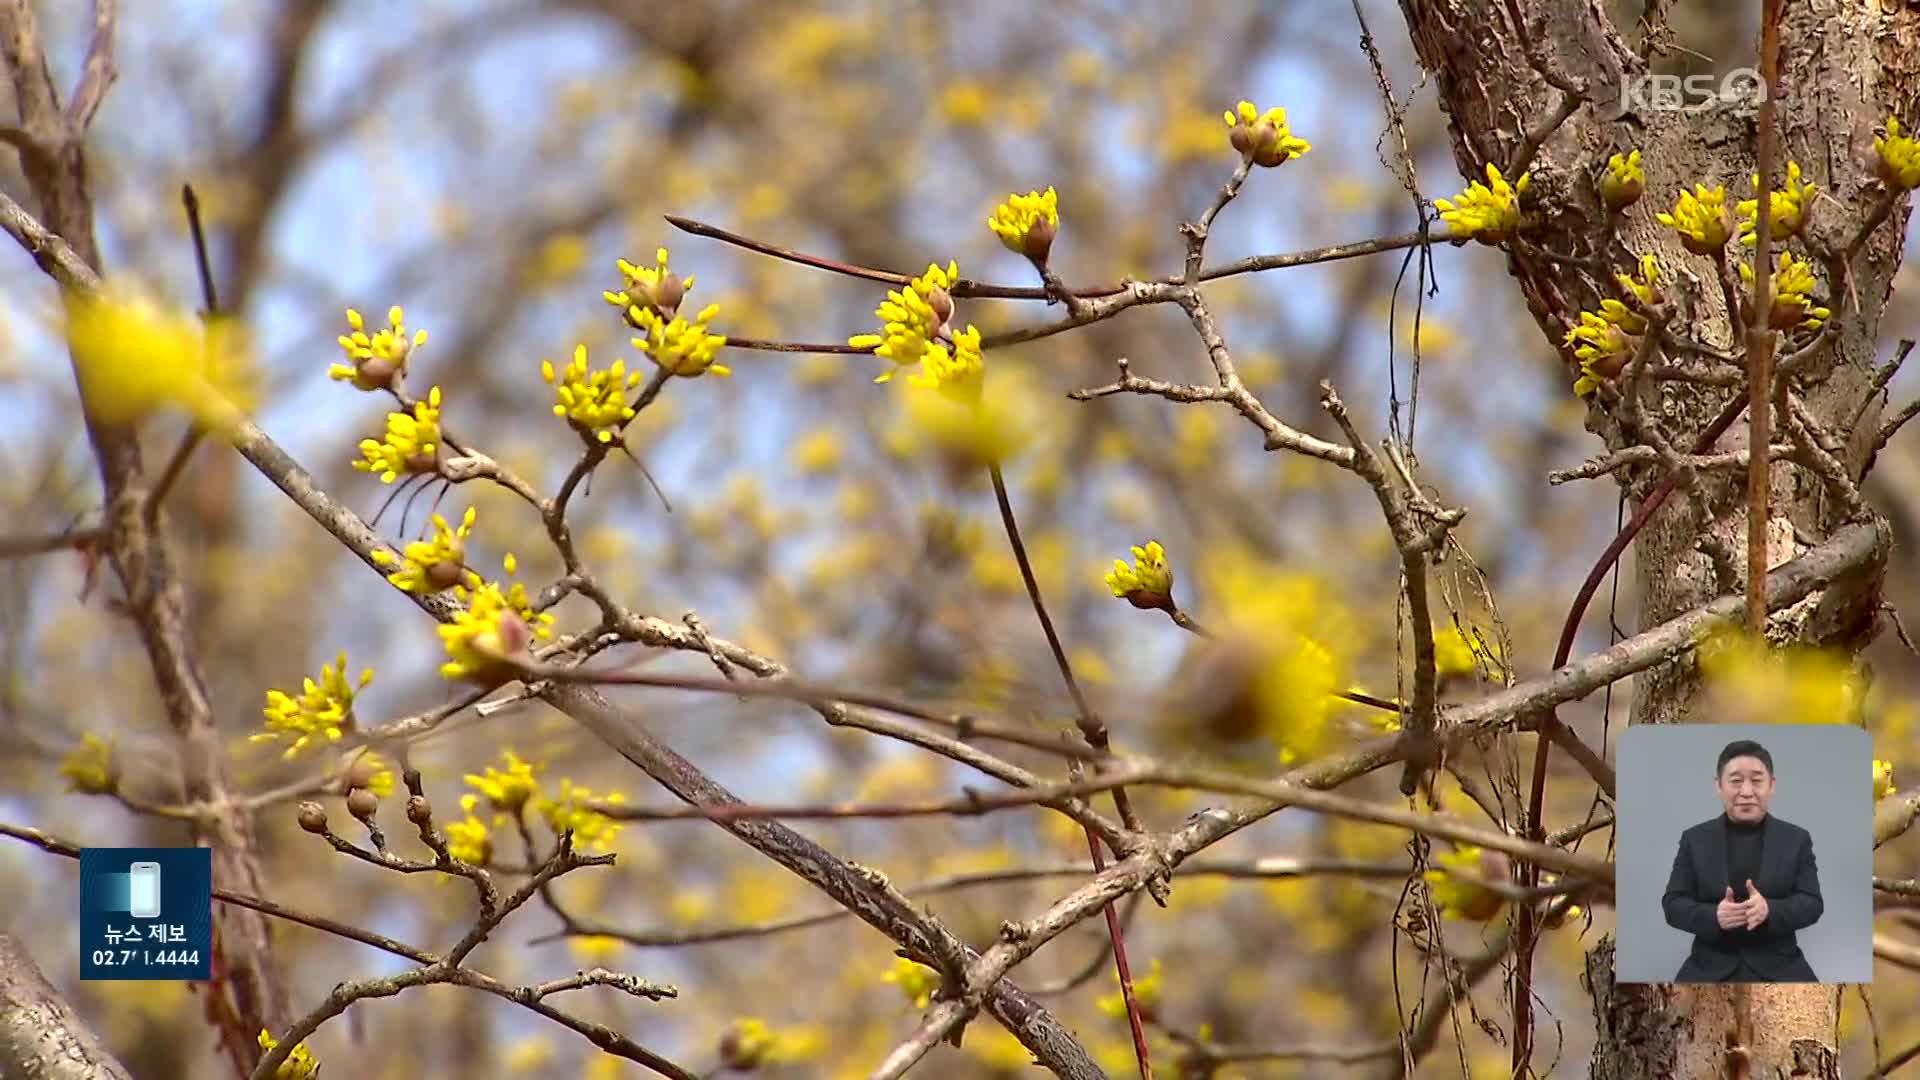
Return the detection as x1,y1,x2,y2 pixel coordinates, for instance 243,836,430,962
1661,740,1826,982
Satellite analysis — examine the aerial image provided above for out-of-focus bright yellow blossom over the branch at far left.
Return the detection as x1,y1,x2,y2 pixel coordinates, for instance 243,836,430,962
65,284,253,430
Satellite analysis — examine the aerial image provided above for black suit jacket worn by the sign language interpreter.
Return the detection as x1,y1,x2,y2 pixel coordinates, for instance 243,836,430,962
1661,815,1826,982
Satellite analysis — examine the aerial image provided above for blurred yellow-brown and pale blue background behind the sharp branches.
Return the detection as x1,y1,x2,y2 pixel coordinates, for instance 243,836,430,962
0,0,1920,1078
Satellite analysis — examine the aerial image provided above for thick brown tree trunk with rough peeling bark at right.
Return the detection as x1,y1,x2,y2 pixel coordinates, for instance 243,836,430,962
1402,0,1920,1080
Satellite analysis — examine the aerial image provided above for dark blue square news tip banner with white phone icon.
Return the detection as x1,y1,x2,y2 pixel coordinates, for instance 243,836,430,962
81,847,213,980
